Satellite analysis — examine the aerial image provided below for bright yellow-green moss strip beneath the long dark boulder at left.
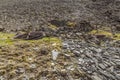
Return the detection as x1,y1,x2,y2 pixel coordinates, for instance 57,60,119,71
0,32,61,45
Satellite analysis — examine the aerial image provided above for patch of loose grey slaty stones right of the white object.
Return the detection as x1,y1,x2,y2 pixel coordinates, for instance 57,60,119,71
63,39,120,80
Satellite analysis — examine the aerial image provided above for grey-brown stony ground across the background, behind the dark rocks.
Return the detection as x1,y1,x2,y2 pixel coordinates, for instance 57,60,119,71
0,0,120,31
